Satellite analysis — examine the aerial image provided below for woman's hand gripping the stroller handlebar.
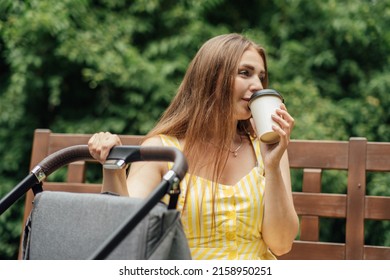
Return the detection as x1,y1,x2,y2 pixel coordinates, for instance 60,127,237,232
88,132,122,164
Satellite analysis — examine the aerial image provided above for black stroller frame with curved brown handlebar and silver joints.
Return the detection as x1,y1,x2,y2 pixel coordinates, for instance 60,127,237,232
0,145,188,260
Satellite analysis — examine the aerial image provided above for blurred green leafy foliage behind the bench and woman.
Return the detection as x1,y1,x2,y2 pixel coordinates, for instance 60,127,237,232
0,0,390,259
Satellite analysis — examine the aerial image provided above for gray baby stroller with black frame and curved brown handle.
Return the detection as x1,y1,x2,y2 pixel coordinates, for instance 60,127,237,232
0,145,191,260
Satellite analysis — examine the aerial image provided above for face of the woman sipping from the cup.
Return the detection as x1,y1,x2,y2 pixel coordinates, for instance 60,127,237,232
233,48,265,120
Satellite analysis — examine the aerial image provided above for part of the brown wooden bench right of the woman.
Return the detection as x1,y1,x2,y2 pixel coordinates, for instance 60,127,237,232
280,138,390,259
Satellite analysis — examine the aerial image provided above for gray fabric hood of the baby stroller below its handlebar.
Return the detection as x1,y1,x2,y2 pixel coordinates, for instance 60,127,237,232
23,191,191,260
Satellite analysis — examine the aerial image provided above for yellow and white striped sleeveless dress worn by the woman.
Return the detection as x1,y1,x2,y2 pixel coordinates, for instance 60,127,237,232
160,135,276,260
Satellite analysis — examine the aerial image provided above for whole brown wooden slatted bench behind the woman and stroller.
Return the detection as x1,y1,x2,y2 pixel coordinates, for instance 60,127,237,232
19,129,390,260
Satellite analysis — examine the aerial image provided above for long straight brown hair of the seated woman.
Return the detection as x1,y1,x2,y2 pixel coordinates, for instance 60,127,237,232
147,33,268,218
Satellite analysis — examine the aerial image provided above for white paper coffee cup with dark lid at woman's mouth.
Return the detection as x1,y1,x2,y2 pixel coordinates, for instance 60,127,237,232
248,89,284,144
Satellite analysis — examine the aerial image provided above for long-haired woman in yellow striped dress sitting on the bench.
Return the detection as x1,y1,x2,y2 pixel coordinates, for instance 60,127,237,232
89,34,298,259
